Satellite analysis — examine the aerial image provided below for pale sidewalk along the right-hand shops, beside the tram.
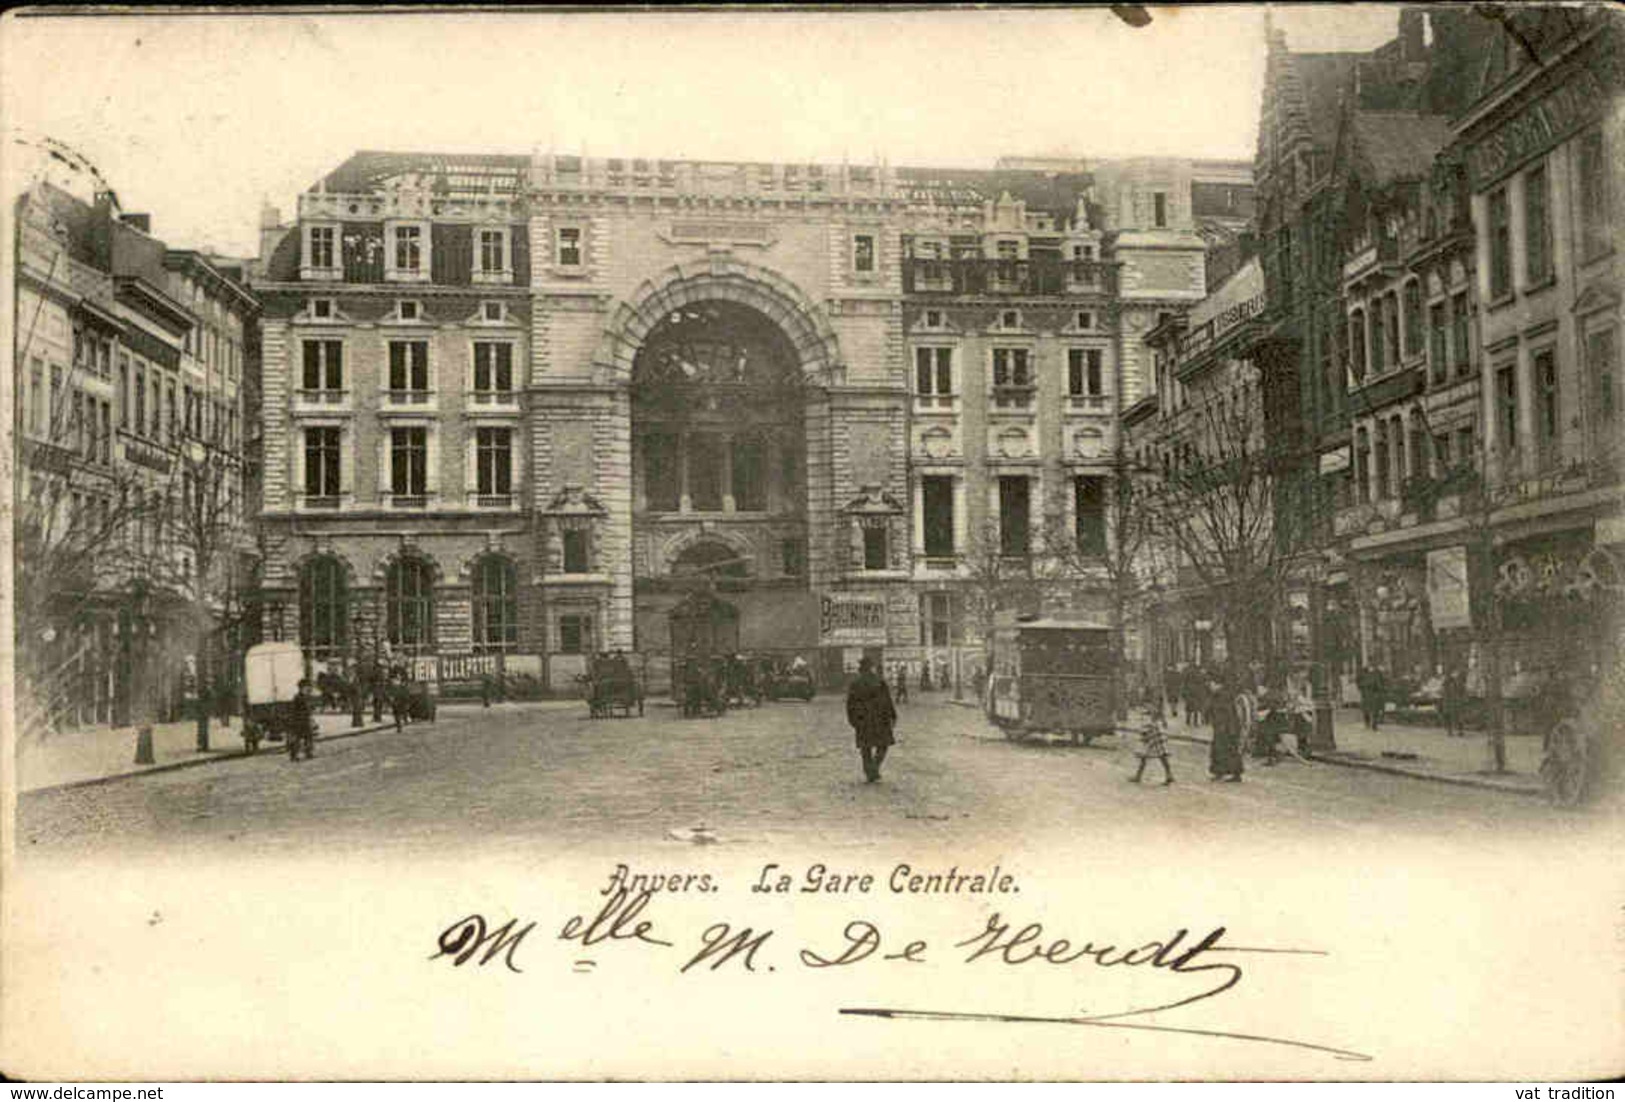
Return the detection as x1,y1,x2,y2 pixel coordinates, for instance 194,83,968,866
1150,709,1544,795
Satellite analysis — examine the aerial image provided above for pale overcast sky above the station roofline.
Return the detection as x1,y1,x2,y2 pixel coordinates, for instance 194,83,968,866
0,7,1398,254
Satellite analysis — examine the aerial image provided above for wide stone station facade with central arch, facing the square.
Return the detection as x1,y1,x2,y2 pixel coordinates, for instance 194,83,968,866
255,153,1250,689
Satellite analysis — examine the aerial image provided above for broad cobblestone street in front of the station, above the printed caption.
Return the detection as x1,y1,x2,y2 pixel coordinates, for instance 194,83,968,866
18,696,1575,855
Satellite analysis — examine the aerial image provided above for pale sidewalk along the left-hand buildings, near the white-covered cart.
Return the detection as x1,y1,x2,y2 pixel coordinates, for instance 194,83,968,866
16,712,393,793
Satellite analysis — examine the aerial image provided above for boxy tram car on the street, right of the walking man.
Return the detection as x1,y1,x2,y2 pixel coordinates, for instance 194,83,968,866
985,619,1116,746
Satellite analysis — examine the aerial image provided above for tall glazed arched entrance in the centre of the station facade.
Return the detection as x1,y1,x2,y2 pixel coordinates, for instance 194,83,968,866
631,297,816,672
